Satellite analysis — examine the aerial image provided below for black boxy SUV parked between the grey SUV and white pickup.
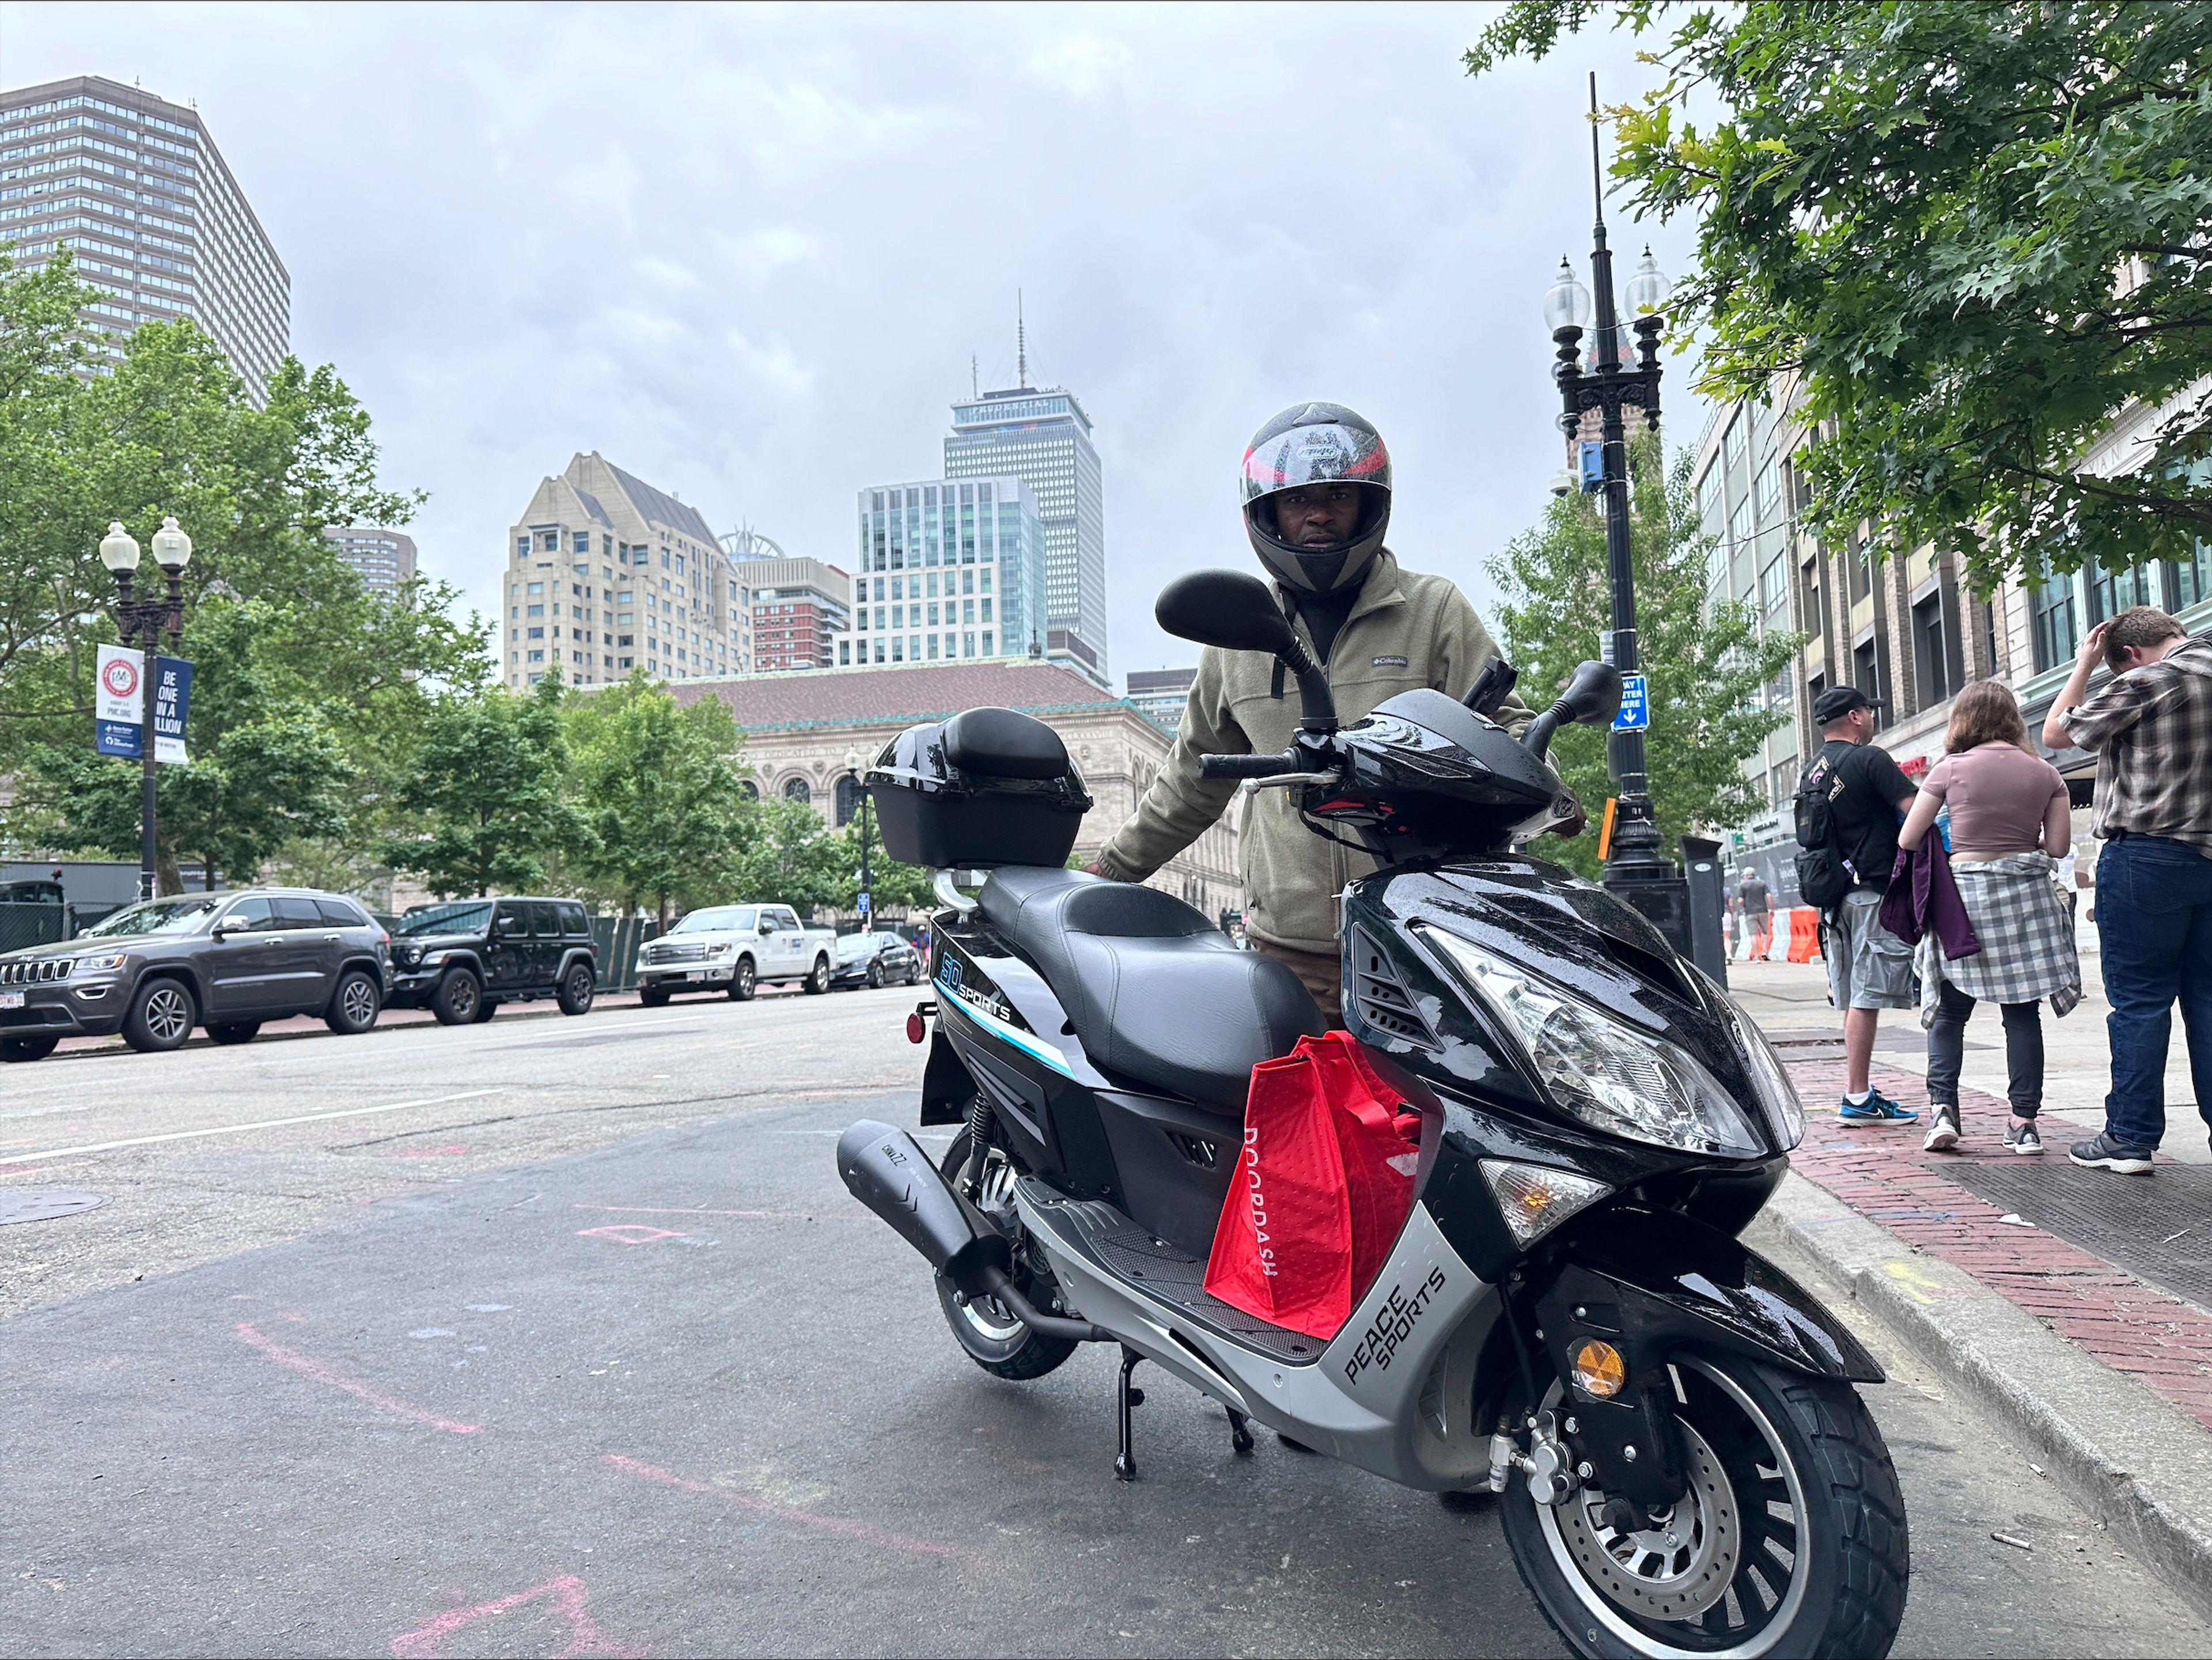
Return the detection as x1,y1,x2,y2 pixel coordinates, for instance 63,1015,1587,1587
392,897,600,1026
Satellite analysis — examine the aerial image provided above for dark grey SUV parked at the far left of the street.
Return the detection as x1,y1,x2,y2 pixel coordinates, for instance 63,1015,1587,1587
0,889,389,1061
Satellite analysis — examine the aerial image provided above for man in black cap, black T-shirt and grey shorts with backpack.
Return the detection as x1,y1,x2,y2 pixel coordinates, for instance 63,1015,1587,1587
1798,685,1920,1125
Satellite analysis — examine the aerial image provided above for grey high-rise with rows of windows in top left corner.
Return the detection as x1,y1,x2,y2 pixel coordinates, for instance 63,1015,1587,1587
0,75,292,402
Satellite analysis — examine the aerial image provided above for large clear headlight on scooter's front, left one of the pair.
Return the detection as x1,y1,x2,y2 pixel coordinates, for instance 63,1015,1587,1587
1420,928,1765,1158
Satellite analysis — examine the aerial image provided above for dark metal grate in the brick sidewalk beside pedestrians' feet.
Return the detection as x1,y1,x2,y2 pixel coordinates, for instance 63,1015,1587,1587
1942,1143,2212,1309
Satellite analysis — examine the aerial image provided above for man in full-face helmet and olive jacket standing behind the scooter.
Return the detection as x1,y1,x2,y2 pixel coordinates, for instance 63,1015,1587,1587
1090,402,1528,1021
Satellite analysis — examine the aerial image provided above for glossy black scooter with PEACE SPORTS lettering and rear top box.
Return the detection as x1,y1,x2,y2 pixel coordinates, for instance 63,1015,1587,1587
838,570,1909,1655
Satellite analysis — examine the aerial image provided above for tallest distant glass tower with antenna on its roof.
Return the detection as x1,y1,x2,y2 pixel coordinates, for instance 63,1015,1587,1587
945,336,1111,687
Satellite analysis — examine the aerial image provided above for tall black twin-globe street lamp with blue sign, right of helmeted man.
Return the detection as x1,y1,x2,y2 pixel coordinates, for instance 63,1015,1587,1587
1544,75,1692,957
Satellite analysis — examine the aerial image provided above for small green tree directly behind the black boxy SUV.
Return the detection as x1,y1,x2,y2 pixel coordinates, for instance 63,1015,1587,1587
382,674,586,895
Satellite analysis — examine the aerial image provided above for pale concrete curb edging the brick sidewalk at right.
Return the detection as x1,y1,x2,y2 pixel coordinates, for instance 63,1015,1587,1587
1745,1172,2212,1618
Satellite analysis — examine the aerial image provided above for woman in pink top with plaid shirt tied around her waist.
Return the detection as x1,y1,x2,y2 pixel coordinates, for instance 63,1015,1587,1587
1898,681,2081,1154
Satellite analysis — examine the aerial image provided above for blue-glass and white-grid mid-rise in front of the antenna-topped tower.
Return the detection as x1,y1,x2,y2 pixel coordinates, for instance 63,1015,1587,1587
836,473,1048,665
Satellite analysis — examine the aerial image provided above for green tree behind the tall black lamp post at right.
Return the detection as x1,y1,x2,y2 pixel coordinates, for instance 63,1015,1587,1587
1486,435,1803,876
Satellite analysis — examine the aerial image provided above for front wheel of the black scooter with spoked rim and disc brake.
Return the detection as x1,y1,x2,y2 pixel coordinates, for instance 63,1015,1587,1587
1502,1355,1911,1660
